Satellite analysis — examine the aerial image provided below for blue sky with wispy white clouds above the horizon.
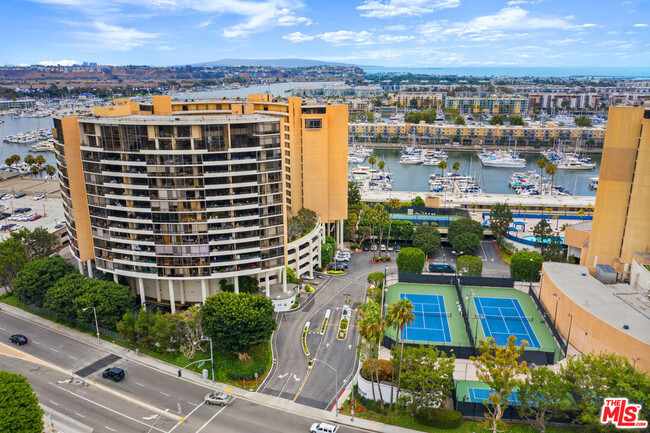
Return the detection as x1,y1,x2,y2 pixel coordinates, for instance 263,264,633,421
0,0,650,67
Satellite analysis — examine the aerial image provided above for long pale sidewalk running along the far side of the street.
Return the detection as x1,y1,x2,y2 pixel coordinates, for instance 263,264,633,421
0,303,417,433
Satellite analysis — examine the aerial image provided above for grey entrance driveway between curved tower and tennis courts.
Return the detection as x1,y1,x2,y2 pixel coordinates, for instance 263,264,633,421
260,248,396,410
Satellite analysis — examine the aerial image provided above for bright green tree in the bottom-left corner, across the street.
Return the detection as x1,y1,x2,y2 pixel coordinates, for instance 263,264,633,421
0,370,44,433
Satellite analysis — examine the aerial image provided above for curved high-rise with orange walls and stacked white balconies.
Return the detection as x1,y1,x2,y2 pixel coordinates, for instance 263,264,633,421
55,95,348,309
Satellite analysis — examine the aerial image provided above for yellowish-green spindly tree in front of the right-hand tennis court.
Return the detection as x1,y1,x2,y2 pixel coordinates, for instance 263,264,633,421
470,335,529,433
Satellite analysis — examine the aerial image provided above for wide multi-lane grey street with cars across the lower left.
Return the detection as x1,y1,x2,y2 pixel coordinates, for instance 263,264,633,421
0,311,361,433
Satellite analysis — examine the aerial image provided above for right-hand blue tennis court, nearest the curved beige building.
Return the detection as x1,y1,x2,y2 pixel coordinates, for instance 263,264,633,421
474,297,540,348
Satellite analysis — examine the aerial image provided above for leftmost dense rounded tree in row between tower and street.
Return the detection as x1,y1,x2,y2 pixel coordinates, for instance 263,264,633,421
13,254,77,306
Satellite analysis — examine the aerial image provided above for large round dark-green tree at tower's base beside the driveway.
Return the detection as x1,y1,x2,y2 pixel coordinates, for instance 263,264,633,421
201,293,278,353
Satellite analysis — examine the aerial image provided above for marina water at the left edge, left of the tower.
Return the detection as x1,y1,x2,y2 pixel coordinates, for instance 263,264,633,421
0,116,56,167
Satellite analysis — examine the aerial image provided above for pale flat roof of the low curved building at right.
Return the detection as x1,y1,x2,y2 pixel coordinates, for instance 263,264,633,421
543,262,650,344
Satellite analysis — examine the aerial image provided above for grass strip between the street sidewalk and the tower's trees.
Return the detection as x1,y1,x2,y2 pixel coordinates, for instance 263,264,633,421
0,295,272,389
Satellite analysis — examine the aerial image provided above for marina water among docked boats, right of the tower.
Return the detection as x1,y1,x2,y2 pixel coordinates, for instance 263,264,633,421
349,149,601,196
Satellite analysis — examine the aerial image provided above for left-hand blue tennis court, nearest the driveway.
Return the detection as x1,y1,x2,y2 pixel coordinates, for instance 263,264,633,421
400,293,451,343
